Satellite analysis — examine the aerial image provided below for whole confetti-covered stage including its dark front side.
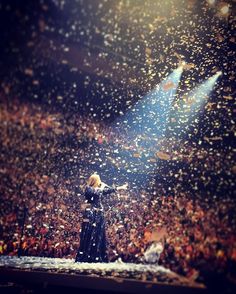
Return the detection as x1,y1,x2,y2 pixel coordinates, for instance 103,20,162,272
0,256,205,293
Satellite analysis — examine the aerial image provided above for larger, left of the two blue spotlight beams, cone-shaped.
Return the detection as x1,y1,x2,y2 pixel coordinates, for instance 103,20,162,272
118,66,183,138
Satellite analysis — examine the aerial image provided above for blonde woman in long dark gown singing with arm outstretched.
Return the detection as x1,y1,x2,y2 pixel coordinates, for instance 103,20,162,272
75,174,127,262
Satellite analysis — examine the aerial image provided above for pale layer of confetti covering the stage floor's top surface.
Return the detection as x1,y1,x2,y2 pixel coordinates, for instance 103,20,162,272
0,256,203,288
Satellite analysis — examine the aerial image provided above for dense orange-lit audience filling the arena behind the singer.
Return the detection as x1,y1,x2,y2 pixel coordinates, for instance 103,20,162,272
0,101,236,284
